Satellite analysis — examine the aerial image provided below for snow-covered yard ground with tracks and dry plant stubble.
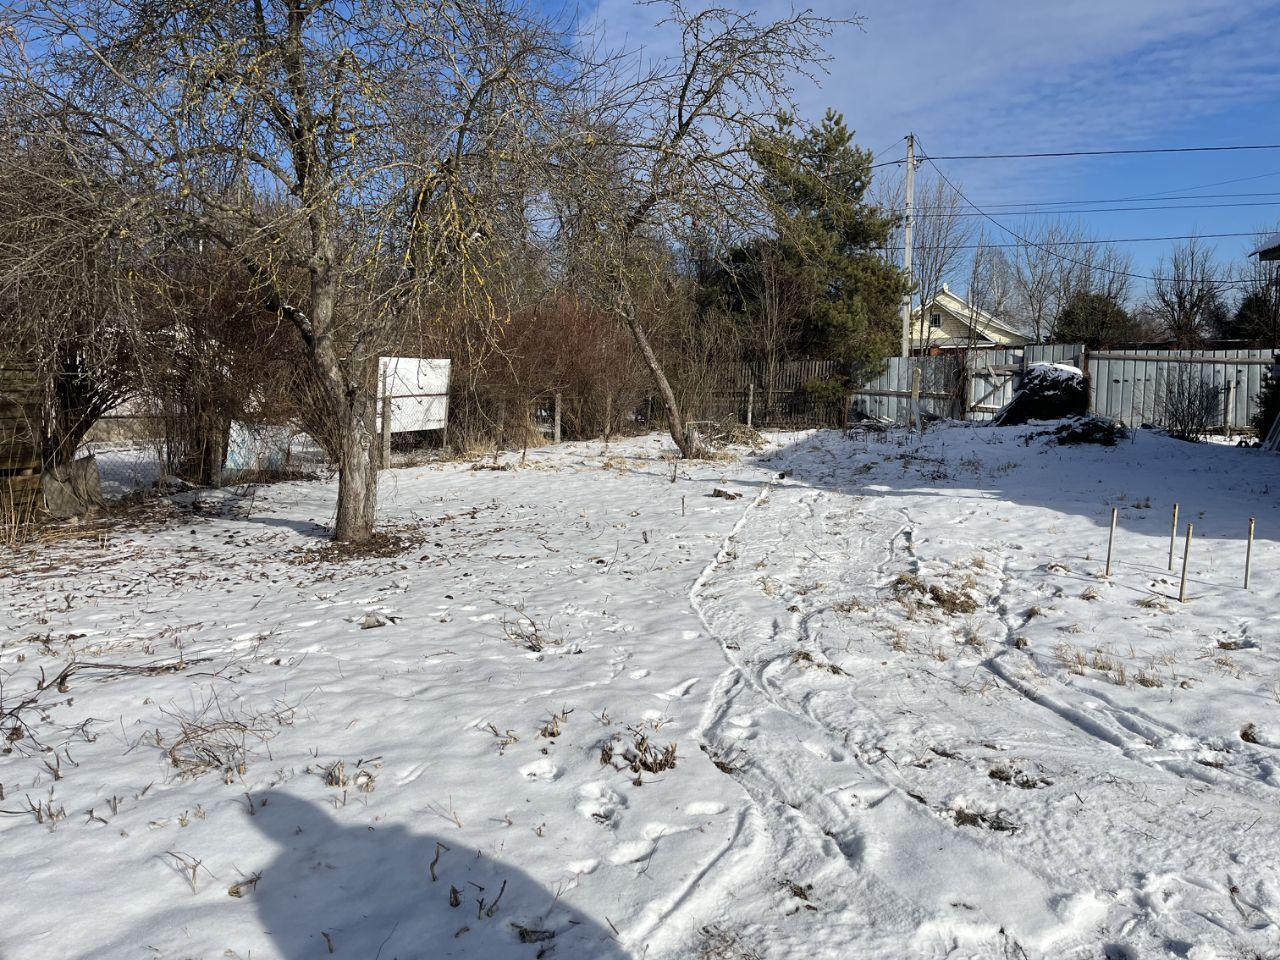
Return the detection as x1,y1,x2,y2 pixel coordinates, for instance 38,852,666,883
0,426,1280,960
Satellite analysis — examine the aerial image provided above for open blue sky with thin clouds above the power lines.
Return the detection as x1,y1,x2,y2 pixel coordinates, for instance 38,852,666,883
595,0,1280,293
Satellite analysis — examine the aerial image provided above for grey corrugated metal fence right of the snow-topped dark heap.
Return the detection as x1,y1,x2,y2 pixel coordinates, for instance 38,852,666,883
1089,349,1275,429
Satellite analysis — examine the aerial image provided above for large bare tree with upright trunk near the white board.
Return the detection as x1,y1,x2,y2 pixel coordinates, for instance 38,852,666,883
4,0,576,541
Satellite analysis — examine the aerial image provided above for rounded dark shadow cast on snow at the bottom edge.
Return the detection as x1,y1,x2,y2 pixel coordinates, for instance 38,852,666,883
252,794,630,960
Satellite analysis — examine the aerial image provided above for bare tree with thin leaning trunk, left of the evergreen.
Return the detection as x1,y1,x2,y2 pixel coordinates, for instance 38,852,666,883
572,0,849,457
